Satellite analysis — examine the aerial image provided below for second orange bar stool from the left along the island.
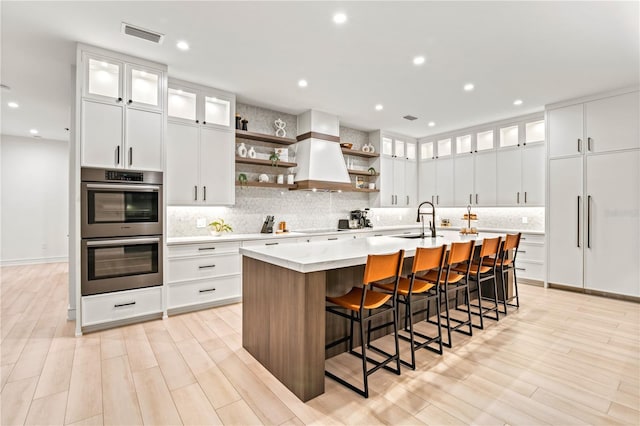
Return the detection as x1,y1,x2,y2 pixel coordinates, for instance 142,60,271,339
373,245,447,370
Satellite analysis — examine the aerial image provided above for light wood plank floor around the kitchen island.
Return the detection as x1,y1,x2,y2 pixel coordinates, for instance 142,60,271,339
0,264,640,425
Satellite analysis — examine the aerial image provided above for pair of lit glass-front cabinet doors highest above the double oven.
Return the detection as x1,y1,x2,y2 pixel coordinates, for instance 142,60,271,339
82,52,163,111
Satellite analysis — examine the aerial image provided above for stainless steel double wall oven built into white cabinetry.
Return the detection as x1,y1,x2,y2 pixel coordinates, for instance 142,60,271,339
80,167,164,296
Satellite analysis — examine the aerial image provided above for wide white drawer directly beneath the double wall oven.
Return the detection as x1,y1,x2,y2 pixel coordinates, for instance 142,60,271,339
82,287,162,327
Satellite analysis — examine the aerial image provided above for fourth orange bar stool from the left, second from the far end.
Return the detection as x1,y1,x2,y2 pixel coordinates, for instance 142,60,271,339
453,237,502,329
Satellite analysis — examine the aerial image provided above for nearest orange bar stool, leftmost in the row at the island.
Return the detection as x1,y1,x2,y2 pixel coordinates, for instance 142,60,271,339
325,250,404,398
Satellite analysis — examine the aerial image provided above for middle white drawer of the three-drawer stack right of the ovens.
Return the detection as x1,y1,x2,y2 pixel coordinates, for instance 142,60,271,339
167,253,240,282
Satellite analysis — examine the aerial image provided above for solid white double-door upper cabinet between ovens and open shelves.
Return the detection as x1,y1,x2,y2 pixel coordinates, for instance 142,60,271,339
167,121,235,205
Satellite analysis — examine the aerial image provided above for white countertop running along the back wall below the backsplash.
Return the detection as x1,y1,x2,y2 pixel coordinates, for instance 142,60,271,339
167,224,544,245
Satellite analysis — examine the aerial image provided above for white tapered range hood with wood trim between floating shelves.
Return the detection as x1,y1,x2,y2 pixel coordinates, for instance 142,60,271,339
295,110,353,191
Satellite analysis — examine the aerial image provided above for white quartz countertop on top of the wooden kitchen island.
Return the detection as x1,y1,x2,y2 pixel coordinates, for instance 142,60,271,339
240,230,504,273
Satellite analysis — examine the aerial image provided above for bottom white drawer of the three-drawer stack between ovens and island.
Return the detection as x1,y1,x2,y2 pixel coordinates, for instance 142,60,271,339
167,275,242,309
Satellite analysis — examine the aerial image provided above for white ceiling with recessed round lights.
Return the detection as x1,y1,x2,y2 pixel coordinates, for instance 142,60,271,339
0,1,640,140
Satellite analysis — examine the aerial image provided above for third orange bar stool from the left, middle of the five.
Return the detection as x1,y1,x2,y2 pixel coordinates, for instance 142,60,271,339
417,240,475,348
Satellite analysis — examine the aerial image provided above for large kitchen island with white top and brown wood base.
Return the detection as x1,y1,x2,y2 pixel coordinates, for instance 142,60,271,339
240,231,503,401
